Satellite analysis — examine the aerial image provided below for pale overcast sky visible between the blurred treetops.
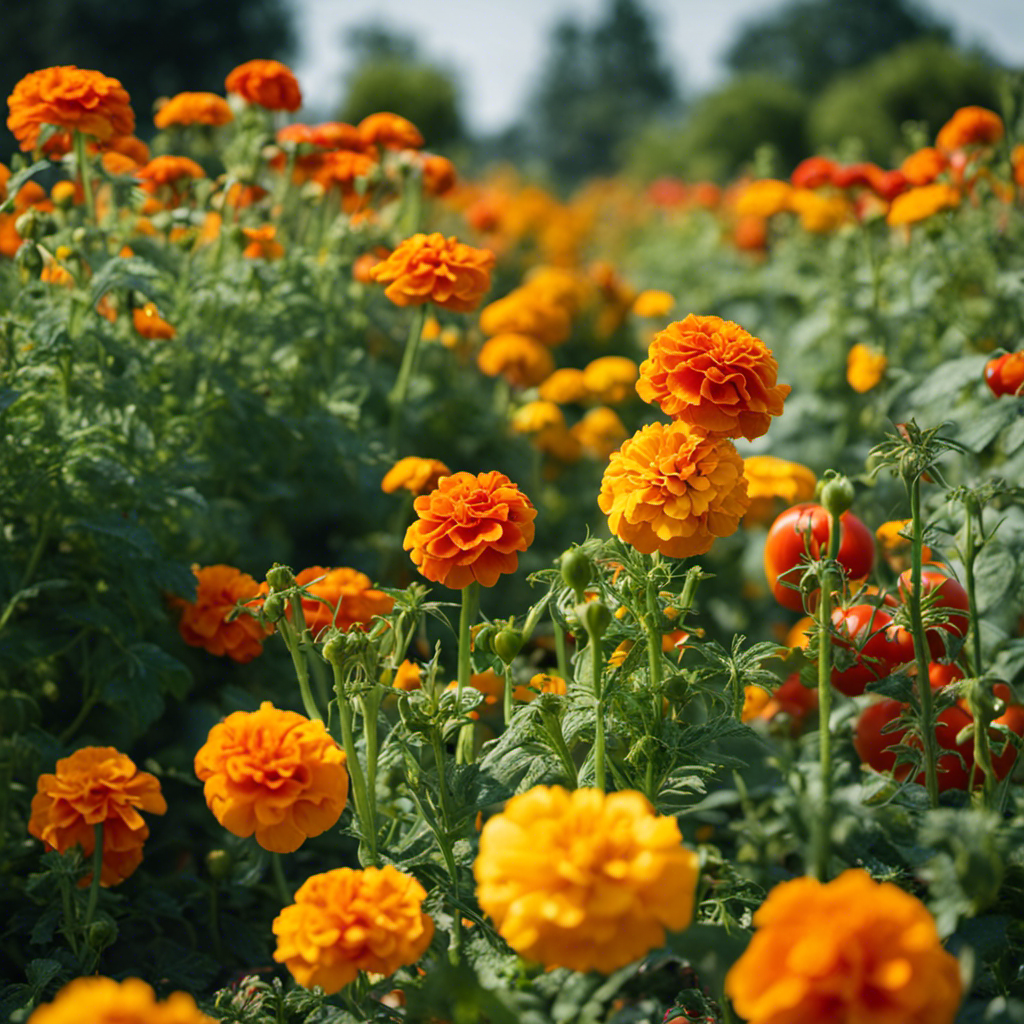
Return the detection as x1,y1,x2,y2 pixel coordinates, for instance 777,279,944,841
294,0,1024,132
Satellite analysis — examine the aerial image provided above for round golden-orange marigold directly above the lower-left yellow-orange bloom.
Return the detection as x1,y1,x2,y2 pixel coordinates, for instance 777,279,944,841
195,700,348,853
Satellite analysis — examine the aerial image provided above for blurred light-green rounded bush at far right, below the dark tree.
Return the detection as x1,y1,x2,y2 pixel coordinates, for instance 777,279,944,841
809,40,999,163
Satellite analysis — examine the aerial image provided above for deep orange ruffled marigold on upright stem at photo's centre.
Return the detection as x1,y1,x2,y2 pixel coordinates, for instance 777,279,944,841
402,470,537,590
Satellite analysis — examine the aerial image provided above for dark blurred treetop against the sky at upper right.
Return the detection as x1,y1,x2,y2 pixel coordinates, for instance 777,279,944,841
725,0,951,93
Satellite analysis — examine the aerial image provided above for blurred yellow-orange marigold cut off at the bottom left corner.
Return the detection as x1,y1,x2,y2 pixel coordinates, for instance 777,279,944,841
28,977,216,1024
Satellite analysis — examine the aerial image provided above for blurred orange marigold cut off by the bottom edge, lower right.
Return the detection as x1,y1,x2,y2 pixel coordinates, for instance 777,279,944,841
725,869,961,1024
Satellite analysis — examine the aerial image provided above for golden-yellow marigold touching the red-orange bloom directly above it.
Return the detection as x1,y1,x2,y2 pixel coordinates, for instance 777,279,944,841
597,421,750,558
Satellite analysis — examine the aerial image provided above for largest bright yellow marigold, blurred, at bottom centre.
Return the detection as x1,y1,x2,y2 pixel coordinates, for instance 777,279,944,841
473,785,697,974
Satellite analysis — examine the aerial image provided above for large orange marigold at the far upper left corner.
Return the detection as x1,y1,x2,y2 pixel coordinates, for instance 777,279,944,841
7,65,135,152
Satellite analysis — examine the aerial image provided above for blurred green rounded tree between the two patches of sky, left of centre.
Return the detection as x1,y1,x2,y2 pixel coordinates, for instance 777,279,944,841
338,24,465,150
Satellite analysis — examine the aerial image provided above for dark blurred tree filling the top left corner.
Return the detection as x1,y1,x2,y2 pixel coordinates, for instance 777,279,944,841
0,0,295,144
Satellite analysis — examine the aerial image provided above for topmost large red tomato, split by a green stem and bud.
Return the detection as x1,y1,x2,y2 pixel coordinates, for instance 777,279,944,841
765,503,874,611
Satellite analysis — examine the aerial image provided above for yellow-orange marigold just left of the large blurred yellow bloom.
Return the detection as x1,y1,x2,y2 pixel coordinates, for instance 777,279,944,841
272,864,434,994
